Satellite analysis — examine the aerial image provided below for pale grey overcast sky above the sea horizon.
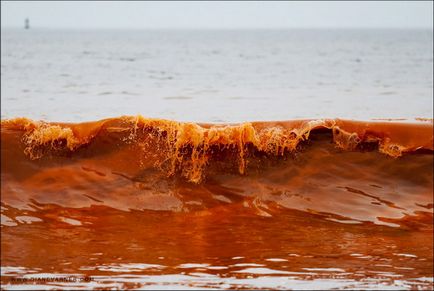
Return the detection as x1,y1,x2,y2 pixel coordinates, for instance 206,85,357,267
1,1,433,29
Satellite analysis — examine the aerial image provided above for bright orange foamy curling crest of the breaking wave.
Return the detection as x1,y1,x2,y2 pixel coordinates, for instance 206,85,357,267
1,116,433,183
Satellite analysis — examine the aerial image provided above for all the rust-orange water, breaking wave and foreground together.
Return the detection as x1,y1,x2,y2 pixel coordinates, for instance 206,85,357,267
1,116,434,289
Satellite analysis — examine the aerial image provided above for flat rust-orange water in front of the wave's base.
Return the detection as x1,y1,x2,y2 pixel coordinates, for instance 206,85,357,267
1,204,432,290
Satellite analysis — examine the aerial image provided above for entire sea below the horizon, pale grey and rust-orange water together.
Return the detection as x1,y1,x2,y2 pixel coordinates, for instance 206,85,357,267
1,29,434,290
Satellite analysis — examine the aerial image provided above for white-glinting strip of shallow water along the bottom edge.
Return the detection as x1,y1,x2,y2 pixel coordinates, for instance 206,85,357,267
2,266,433,290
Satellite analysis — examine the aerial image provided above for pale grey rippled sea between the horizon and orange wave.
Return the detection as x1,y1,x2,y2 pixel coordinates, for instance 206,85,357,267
1,29,433,122
